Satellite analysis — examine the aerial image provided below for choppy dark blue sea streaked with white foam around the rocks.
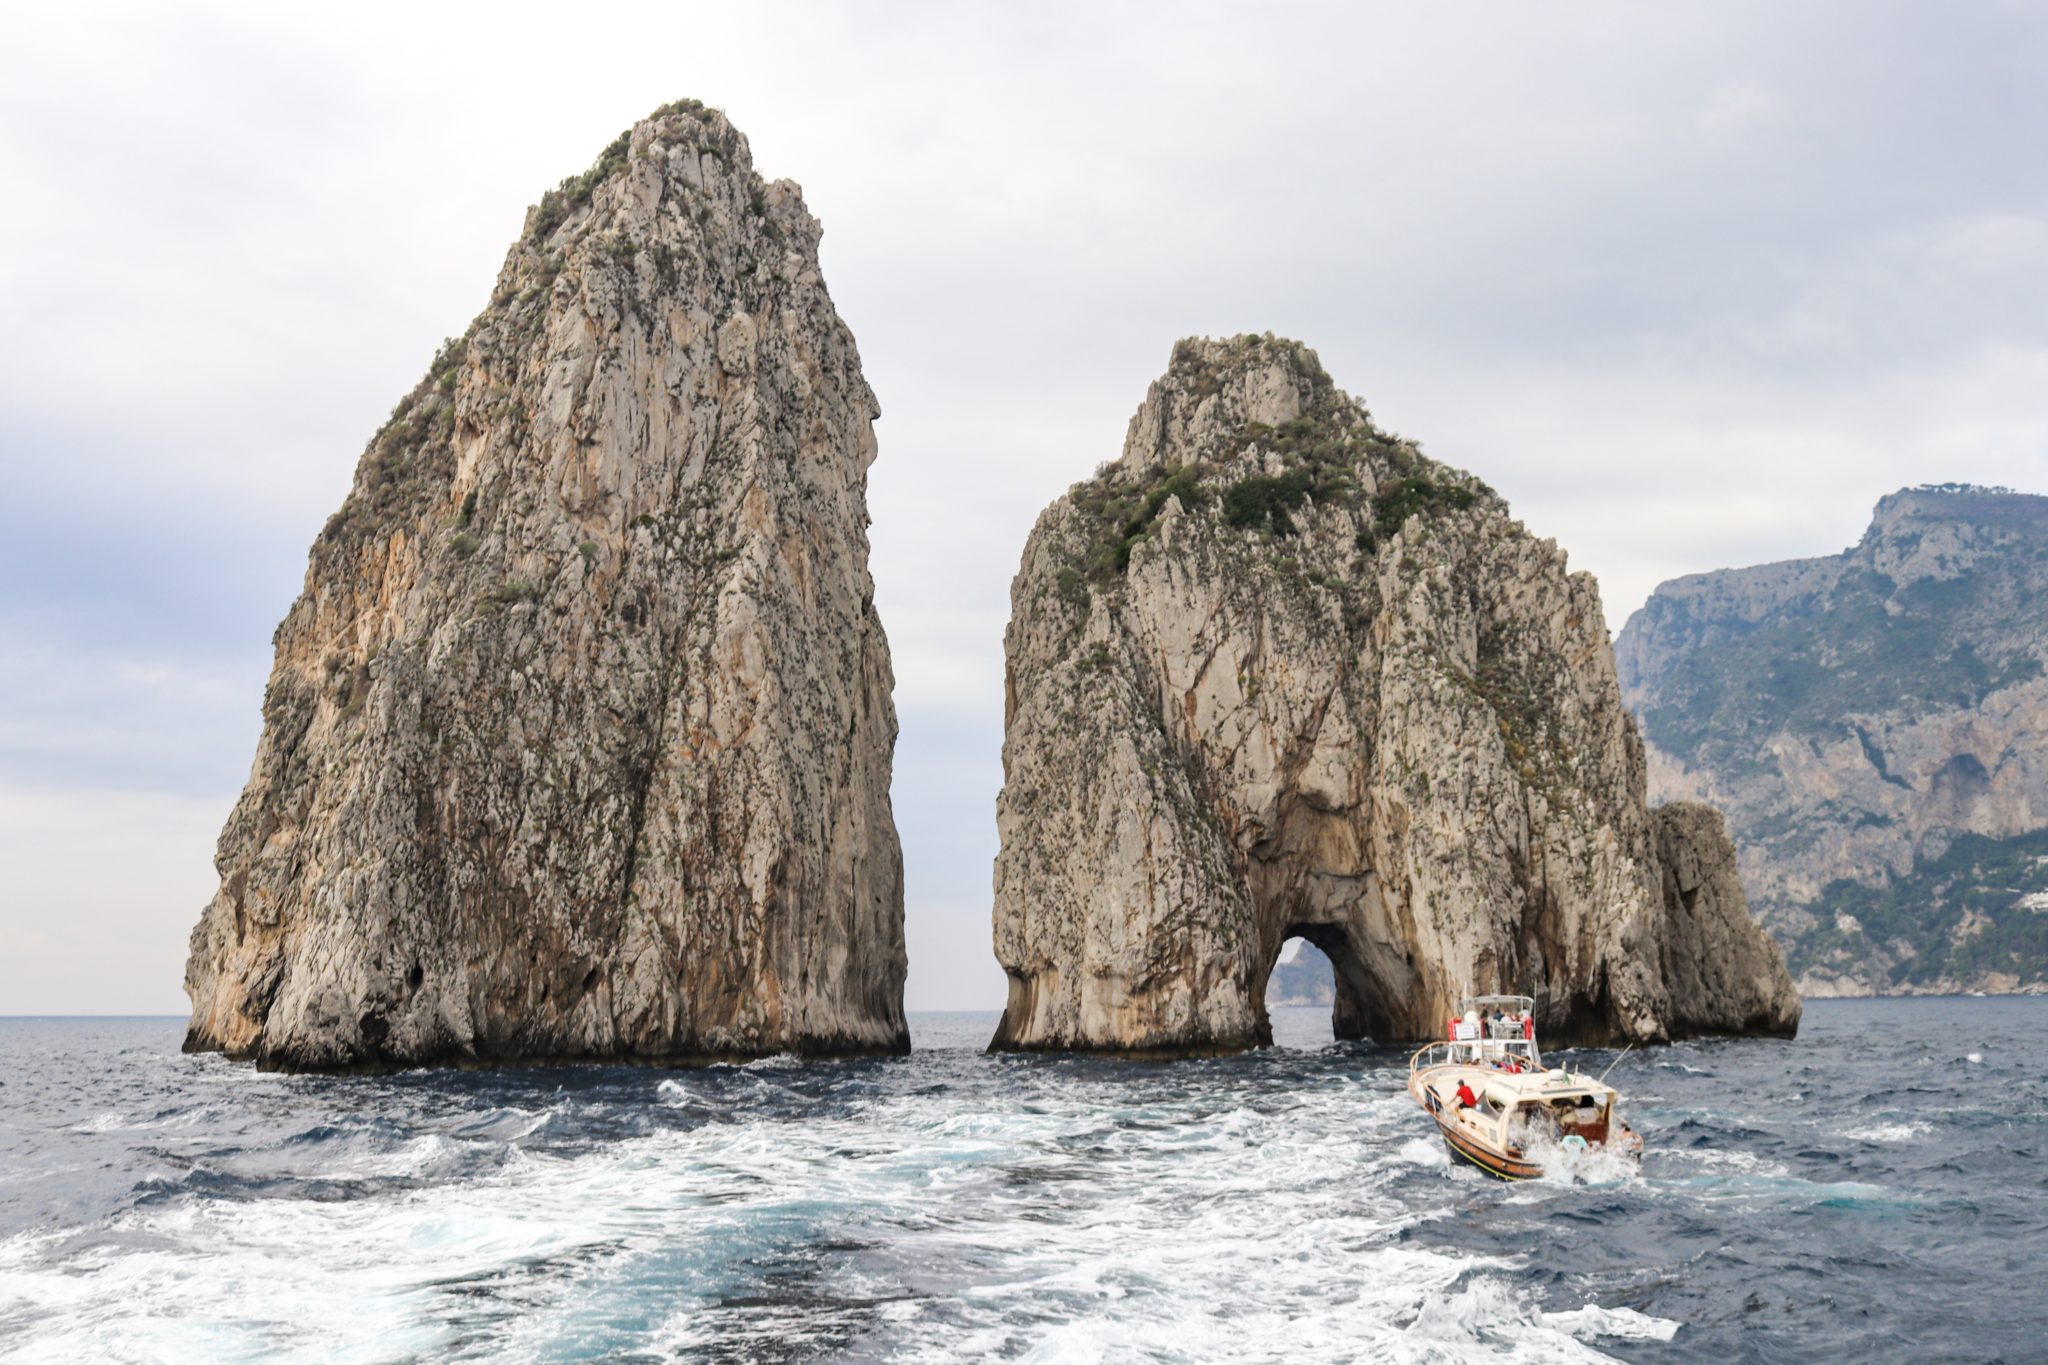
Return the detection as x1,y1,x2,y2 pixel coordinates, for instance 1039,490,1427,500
0,999,2048,1361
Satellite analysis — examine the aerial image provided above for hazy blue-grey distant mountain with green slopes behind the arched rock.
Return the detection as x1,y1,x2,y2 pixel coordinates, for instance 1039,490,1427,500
1614,485,2048,995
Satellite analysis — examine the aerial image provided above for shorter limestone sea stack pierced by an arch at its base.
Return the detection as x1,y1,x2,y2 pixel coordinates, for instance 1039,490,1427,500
995,338,1798,1054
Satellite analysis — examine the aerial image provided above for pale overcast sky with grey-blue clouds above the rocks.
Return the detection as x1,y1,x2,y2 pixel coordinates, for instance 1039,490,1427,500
0,0,2048,1015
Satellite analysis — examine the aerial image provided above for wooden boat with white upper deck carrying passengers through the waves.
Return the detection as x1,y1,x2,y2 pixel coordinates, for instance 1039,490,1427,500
1409,995,1642,1181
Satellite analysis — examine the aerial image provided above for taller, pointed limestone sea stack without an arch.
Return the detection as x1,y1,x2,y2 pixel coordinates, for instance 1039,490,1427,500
186,102,907,1068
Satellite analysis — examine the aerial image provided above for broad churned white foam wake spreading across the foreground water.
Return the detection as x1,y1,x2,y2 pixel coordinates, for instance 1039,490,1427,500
0,1064,1687,1361
